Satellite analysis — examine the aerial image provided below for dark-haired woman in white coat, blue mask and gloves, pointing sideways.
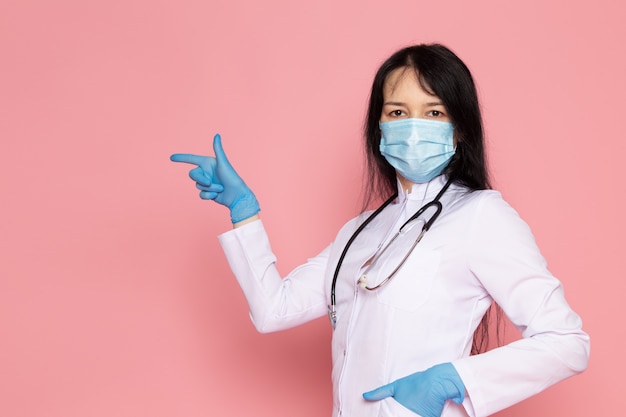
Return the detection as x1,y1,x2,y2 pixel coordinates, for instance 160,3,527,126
171,45,589,417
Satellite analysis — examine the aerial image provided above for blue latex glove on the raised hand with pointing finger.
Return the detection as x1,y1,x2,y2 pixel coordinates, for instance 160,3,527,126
170,134,261,223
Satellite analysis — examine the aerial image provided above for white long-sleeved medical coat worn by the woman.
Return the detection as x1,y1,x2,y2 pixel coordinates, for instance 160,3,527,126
219,176,589,417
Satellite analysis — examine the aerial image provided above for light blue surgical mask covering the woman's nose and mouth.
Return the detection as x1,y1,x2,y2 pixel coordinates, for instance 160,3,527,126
379,118,456,183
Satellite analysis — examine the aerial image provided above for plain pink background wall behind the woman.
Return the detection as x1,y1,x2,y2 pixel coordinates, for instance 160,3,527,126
0,0,626,417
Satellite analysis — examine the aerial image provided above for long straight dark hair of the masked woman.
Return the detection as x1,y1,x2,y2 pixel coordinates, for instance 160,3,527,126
364,44,502,354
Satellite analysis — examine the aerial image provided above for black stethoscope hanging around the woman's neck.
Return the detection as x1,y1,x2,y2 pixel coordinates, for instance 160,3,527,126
328,179,452,330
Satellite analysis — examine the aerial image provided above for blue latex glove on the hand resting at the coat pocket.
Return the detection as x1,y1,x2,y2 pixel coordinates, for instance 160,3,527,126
363,362,465,417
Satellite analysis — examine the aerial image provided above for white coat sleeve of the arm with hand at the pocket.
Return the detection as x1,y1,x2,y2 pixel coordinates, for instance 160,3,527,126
453,192,589,416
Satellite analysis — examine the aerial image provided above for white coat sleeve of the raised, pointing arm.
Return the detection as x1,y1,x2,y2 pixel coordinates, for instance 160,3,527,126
218,220,330,333
